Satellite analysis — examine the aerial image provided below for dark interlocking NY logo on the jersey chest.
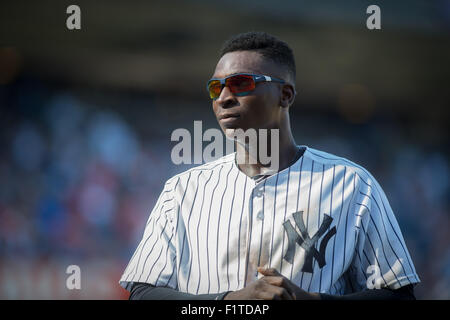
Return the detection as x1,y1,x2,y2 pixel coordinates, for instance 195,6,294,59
283,211,336,273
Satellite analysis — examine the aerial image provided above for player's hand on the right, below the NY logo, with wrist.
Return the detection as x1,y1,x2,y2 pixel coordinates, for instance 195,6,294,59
258,267,320,300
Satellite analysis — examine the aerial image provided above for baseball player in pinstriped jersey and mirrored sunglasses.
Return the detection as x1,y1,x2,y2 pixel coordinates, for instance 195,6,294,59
120,32,420,300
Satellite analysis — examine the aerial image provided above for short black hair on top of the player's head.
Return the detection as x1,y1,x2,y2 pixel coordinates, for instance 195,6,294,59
220,31,296,81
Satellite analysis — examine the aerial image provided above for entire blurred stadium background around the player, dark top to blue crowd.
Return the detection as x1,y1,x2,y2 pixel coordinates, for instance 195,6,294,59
0,0,450,299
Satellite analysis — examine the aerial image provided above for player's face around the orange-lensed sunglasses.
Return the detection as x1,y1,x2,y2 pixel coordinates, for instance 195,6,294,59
213,51,286,133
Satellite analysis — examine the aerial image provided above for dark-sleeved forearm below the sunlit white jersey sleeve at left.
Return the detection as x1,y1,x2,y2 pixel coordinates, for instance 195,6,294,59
129,282,230,300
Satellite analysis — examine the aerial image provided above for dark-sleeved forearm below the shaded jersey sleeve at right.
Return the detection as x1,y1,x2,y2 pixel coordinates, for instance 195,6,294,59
320,285,416,300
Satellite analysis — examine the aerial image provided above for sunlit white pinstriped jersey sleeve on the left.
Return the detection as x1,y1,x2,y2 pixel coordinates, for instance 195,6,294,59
119,183,176,291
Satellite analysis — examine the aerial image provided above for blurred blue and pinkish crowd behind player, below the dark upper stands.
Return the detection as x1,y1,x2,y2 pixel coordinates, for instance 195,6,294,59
0,76,450,299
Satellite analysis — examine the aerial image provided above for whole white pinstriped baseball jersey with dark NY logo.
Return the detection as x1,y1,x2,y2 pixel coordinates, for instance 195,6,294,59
120,146,420,295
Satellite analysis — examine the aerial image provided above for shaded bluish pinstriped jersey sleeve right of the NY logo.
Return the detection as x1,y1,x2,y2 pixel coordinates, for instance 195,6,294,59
350,176,420,291
